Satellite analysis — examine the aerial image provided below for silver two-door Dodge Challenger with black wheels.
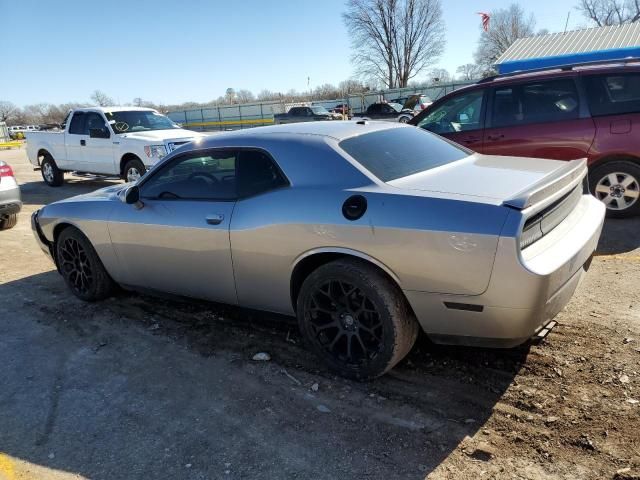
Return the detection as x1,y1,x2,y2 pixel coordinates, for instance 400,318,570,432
32,121,605,379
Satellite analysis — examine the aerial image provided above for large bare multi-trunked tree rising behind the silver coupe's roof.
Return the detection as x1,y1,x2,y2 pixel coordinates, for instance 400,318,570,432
342,0,445,88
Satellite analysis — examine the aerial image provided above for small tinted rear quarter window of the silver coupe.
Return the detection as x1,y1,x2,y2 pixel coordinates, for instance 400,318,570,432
238,150,287,197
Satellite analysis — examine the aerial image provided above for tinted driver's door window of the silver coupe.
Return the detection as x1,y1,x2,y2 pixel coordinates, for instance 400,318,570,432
140,150,237,200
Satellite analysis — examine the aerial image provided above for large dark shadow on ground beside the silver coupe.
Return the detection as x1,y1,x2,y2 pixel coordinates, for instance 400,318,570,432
0,272,528,480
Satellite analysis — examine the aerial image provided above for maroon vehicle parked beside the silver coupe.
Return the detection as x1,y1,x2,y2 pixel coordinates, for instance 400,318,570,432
409,63,640,217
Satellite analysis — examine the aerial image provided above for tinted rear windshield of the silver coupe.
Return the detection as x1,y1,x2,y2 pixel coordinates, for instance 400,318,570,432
340,127,470,182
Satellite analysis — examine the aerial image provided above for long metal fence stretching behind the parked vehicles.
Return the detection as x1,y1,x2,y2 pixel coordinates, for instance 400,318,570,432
167,82,472,131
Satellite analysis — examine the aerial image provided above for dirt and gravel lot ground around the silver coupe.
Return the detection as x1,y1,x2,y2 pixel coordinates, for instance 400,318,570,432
0,150,640,480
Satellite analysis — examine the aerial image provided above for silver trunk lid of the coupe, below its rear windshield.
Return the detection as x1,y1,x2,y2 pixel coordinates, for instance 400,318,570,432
388,153,584,208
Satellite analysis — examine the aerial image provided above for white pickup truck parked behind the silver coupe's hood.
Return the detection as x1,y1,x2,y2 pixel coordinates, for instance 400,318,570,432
27,107,205,187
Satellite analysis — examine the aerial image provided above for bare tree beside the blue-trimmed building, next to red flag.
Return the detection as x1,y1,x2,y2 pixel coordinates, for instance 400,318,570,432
475,3,536,74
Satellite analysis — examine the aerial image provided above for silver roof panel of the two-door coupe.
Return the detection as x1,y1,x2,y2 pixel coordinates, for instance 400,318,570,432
200,120,404,147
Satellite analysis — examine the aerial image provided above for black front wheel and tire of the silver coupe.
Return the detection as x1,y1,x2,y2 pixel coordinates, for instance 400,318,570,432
55,227,115,302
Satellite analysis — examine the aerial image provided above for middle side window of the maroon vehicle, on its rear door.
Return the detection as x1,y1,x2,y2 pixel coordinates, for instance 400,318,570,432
491,79,579,127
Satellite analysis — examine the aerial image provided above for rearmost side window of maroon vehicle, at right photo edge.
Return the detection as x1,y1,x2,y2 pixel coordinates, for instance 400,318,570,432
585,73,640,116
